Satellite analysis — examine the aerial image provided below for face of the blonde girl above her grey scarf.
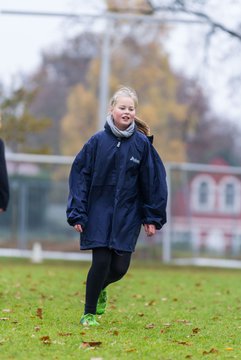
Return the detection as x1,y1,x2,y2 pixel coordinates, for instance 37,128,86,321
111,96,136,130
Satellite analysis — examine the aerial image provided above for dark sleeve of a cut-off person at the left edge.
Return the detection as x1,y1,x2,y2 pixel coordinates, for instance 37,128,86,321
0,139,9,211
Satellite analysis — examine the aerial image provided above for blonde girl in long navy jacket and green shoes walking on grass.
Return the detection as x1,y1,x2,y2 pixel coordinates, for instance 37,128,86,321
67,87,167,326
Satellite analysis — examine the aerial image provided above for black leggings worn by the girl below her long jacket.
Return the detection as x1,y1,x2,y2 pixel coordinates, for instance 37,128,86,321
85,248,132,314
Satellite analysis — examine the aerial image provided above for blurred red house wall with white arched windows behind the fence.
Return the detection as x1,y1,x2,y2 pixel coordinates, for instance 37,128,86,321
170,163,241,257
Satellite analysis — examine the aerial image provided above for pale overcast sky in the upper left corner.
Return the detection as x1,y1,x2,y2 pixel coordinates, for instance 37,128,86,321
0,0,101,85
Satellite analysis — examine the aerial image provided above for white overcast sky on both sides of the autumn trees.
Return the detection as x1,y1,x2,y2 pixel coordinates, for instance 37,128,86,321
0,0,241,121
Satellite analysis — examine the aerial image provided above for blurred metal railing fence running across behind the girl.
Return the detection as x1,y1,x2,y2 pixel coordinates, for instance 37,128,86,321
0,153,241,267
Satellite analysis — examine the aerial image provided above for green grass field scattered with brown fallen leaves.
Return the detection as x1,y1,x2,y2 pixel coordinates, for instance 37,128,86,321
0,259,241,360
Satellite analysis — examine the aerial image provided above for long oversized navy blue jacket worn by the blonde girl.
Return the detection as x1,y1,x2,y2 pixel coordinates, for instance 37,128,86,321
67,124,167,252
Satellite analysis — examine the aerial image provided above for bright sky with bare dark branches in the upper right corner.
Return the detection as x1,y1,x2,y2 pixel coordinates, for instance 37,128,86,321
141,0,241,121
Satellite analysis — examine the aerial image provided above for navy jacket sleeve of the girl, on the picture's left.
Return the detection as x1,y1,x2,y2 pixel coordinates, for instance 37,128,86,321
66,142,92,227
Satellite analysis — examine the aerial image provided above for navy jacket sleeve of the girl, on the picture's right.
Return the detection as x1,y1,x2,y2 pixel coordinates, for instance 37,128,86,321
140,143,167,229
